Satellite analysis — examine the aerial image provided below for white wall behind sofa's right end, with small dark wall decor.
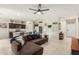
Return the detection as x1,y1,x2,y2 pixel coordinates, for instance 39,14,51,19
42,18,59,40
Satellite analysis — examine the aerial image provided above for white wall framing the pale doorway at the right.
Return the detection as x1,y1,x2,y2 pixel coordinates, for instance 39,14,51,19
61,16,78,38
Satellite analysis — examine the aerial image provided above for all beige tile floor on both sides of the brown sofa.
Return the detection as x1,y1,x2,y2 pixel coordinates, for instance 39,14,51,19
0,37,71,55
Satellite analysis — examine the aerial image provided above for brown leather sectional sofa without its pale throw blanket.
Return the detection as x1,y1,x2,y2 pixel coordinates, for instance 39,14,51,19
11,36,48,55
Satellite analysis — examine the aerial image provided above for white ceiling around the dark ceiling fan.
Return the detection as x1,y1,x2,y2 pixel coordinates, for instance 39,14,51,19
0,4,79,20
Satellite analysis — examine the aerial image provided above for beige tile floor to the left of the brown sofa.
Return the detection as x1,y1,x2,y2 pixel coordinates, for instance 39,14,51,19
0,39,12,55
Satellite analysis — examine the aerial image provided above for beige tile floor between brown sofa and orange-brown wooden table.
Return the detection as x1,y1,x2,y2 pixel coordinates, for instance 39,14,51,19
42,39,71,55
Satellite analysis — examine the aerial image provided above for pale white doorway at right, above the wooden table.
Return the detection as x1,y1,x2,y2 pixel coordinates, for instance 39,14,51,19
66,19,76,38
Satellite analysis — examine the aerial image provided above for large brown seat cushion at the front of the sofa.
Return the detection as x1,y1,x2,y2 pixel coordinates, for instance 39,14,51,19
18,42,43,55
